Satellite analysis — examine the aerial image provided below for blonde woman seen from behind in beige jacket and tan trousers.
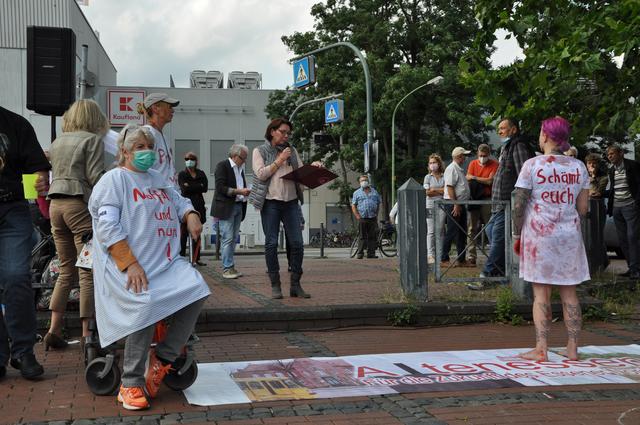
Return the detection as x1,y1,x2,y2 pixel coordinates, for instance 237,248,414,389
44,99,109,350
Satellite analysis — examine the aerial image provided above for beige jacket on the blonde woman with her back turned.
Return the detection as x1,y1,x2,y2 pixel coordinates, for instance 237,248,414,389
49,131,105,203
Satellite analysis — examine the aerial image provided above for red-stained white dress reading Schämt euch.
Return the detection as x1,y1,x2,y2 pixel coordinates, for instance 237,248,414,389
516,155,590,285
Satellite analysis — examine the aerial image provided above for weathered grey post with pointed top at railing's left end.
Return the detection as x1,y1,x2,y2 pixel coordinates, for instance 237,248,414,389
397,178,428,301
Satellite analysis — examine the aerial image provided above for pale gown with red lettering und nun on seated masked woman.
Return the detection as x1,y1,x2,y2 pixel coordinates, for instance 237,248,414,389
89,168,210,347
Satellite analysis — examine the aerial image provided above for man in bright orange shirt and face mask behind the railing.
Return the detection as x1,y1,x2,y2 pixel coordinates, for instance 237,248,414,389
467,143,498,266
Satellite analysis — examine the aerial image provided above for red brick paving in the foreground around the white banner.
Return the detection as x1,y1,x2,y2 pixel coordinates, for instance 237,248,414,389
0,322,640,425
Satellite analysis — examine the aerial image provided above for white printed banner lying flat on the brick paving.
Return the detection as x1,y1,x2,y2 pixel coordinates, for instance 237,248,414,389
184,344,640,406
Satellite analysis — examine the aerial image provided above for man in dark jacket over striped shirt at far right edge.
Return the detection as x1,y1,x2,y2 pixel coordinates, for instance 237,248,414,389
607,145,640,279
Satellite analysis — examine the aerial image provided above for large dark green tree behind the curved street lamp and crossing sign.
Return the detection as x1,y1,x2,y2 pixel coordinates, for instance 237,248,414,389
268,0,486,210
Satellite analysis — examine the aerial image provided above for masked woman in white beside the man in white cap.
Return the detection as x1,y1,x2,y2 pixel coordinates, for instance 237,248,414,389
424,153,445,263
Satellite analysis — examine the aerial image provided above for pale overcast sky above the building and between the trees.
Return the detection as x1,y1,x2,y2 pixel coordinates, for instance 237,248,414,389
81,0,519,89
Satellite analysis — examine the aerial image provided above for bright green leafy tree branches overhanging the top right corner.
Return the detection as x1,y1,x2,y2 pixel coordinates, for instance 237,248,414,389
460,0,640,154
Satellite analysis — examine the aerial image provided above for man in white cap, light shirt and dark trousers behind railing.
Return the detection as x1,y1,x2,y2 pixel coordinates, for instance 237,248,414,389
442,146,471,267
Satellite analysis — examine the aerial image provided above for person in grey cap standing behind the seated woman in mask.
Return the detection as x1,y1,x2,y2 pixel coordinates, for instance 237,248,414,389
138,93,180,187
